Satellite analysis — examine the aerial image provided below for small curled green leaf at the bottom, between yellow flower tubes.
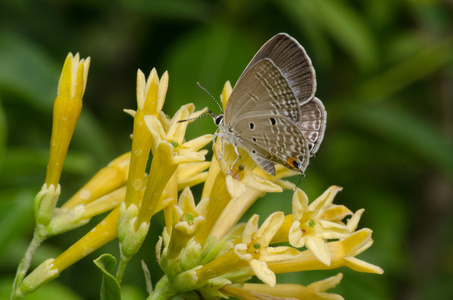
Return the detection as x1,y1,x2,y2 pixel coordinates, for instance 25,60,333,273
94,254,121,300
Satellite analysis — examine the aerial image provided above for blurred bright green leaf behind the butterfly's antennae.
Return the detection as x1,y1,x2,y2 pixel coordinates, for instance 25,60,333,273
159,22,254,139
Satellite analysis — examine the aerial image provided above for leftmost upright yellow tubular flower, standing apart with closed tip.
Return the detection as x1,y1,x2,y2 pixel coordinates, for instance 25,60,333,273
45,53,90,187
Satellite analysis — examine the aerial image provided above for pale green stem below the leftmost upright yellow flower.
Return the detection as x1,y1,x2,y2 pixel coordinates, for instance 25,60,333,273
10,227,46,299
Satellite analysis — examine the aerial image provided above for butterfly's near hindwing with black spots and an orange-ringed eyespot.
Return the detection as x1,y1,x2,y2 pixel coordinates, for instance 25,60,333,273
232,113,310,175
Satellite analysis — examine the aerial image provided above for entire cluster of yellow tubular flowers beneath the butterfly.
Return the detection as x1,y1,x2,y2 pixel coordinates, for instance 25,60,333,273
11,54,383,299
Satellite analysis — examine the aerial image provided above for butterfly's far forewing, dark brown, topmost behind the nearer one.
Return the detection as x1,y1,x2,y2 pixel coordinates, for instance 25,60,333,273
236,33,316,104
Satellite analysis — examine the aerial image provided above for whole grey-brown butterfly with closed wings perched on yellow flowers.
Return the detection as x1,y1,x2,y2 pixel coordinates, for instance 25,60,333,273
211,33,327,176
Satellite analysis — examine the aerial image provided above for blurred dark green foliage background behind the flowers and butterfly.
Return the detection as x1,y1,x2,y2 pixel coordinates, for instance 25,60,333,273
0,0,453,299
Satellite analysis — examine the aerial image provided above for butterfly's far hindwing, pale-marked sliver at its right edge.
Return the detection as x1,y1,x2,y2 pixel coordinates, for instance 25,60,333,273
296,97,327,155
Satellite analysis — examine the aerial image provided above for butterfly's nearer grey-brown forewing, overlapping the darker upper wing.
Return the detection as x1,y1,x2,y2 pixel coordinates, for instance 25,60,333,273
224,59,300,127
